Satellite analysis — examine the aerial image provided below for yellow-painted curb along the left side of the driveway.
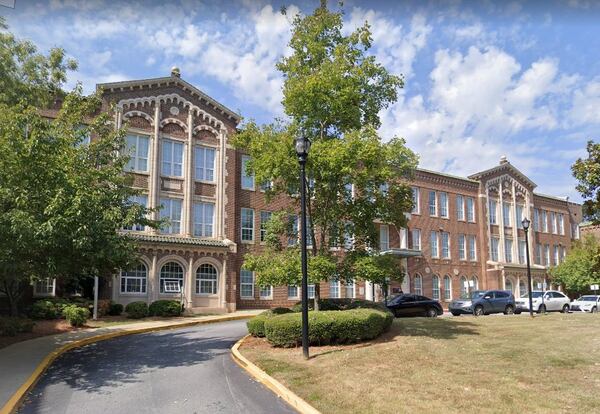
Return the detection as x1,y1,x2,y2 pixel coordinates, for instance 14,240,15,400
0,315,254,414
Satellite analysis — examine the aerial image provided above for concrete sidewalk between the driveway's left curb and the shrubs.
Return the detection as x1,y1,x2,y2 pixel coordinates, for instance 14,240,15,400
0,310,262,410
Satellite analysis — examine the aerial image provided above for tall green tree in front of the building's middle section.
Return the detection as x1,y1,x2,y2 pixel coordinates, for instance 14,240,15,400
234,2,417,306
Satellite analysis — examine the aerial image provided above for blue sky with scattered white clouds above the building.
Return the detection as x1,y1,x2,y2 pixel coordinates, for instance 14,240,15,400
0,0,600,201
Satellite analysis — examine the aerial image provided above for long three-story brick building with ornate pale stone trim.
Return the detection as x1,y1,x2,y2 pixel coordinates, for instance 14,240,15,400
18,69,581,312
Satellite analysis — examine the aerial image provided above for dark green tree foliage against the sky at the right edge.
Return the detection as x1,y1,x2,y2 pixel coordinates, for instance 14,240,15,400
571,141,600,224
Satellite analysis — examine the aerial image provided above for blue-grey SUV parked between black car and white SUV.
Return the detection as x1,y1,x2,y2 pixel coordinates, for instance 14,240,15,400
448,290,515,316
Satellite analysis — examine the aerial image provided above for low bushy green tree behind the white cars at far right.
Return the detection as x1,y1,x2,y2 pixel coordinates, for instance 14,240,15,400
550,235,600,294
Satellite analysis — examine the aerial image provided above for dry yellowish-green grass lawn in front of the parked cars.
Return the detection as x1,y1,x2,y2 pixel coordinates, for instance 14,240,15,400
241,314,600,413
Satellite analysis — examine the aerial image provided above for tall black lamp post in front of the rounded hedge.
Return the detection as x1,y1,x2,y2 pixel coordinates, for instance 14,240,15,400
296,137,310,359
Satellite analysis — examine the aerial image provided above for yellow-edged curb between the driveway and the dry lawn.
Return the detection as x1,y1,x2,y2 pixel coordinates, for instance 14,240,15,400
231,335,321,414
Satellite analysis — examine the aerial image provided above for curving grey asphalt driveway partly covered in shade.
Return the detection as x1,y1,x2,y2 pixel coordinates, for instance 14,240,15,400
19,321,295,414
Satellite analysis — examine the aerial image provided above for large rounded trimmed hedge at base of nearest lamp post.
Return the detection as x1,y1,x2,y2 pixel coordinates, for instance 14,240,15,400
264,309,394,348
